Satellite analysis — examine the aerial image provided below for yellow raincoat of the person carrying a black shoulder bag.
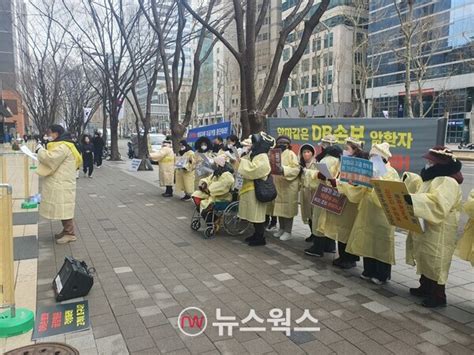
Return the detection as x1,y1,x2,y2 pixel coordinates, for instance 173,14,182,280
239,153,271,223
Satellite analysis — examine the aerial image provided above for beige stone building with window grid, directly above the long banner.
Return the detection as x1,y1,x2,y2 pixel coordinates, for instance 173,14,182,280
277,0,368,117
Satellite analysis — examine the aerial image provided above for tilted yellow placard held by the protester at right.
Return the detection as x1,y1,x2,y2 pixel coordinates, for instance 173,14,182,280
371,179,423,233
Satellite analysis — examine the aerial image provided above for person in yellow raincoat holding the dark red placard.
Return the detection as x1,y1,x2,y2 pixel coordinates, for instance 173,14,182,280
304,135,342,257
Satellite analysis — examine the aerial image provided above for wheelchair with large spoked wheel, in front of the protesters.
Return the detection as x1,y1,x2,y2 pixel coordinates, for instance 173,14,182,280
191,192,250,239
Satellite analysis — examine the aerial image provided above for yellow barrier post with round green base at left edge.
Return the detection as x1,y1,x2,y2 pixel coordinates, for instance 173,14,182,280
0,184,34,338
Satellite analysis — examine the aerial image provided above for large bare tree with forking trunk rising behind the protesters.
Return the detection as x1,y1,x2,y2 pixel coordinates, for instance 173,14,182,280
180,0,330,136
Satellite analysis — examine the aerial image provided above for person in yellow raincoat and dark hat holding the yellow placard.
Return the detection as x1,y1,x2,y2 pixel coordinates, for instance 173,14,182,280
405,146,463,308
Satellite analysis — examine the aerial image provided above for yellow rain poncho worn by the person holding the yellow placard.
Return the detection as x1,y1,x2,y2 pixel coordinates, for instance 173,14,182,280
407,176,462,285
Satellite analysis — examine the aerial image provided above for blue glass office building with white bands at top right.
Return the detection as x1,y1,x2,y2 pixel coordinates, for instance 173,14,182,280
366,0,474,143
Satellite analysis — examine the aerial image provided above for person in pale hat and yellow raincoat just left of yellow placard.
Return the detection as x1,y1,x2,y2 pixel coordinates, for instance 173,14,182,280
344,143,400,285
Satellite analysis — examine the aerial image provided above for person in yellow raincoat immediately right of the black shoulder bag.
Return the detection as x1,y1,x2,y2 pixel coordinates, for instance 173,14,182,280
272,136,300,241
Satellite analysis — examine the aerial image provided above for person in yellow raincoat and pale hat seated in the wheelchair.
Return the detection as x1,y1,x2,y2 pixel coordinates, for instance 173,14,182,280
192,155,234,224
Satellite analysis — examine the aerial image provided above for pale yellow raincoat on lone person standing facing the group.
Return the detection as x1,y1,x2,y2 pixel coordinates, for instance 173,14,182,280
37,144,76,220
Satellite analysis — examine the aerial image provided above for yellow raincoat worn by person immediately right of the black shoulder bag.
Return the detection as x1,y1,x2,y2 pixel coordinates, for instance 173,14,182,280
273,149,300,218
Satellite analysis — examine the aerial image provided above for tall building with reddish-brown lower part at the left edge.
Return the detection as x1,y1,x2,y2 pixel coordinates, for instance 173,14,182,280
0,0,29,140
